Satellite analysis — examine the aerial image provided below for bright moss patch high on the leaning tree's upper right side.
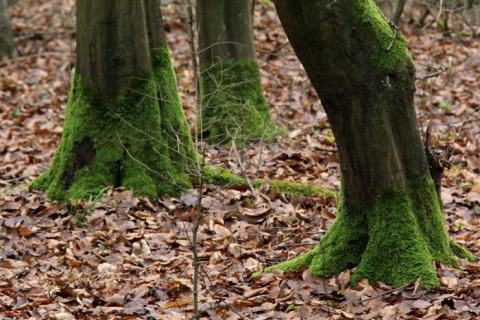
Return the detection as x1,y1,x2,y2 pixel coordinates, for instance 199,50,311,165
353,0,412,73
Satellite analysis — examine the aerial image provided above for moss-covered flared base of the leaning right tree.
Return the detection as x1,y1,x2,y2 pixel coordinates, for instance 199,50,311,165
265,180,476,287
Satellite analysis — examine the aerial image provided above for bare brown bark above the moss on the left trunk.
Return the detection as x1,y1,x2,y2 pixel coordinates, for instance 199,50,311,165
75,0,150,98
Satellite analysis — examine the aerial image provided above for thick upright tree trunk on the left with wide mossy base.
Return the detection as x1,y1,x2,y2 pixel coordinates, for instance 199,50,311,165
32,0,196,199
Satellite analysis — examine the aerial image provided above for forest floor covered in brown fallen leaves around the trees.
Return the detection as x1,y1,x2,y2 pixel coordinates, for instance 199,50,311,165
0,0,480,319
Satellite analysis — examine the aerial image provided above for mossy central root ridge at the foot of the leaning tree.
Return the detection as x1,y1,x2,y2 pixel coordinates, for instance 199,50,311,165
351,185,440,287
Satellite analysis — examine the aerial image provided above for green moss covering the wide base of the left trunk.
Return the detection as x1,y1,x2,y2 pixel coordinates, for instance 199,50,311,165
31,49,195,200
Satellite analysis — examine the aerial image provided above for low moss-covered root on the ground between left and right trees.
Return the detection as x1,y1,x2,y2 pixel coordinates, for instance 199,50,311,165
204,166,336,198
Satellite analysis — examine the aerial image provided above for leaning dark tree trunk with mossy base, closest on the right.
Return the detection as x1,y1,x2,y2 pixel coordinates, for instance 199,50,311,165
268,0,474,286
